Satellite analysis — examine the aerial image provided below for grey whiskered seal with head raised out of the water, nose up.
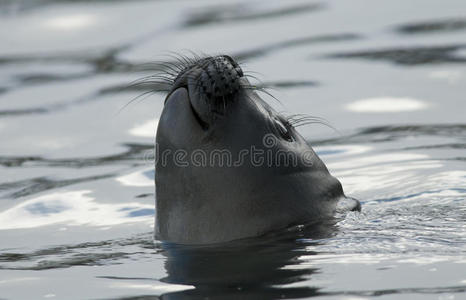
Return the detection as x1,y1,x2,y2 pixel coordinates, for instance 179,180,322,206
155,55,360,244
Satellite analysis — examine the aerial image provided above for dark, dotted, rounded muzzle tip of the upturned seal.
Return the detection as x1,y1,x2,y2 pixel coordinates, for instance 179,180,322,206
200,55,243,100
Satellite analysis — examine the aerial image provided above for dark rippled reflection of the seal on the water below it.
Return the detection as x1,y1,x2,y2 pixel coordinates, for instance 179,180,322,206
161,229,326,299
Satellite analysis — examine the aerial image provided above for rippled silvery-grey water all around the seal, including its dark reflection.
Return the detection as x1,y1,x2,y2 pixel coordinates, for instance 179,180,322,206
0,0,466,300
